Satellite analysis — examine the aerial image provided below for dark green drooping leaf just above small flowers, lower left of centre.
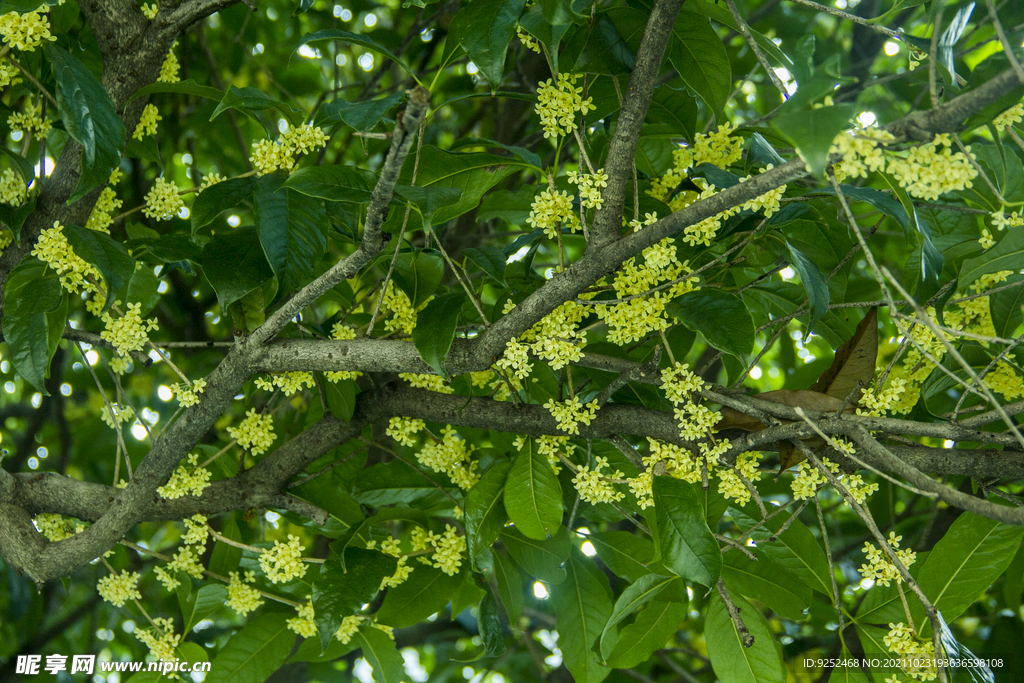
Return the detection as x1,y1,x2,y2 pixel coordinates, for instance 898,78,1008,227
312,548,398,653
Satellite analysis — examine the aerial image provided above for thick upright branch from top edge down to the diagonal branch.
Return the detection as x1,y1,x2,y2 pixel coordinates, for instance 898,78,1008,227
590,0,683,249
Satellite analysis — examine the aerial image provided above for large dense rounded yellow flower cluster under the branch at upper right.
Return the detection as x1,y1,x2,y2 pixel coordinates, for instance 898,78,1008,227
886,133,978,202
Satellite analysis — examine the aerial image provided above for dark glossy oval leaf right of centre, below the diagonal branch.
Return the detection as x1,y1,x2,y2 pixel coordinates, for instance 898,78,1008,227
665,289,754,357
